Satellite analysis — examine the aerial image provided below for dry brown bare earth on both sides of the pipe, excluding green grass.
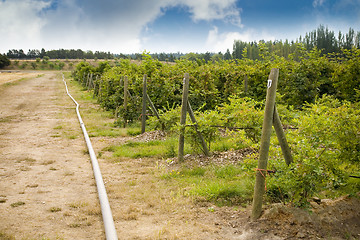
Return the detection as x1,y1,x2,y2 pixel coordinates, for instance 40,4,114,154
0,72,360,239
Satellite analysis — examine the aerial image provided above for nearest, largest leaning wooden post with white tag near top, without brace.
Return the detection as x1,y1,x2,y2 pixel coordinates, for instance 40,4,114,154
251,68,279,220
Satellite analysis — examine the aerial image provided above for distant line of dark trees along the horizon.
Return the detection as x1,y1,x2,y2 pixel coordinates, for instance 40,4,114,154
6,25,360,62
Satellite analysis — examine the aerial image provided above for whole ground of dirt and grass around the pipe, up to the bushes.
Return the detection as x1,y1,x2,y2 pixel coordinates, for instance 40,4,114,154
0,68,360,239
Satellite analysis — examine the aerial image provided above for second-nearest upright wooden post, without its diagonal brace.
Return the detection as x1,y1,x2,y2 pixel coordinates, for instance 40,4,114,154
178,73,189,162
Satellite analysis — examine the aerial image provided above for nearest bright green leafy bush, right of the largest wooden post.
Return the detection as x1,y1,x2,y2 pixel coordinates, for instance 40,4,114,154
268,96,360,206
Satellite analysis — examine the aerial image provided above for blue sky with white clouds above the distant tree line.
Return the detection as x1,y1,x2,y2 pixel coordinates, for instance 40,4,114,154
0,0,360,54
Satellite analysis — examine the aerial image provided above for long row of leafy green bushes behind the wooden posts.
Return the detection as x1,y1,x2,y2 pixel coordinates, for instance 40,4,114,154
73,46,360,205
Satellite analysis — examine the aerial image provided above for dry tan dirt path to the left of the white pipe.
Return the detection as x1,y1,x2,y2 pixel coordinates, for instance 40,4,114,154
0,72,104,239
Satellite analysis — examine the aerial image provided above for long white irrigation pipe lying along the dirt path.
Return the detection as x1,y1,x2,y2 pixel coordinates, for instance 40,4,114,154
62,74,118,240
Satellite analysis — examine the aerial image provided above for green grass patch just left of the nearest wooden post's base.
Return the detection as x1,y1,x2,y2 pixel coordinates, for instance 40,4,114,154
160,165,255,206
